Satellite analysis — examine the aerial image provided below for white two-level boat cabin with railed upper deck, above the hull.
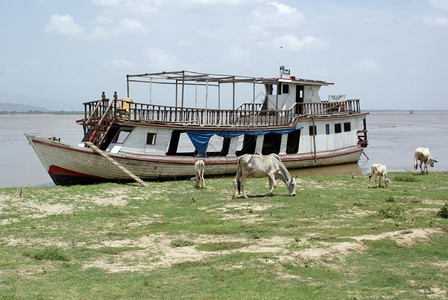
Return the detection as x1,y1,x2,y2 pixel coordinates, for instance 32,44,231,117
79,71,367,157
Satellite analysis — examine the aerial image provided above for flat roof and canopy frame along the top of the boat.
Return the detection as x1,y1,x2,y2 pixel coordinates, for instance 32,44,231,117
126,70,334,86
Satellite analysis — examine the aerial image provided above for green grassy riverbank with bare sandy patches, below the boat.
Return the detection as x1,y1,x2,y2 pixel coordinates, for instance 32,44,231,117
0,172,448,299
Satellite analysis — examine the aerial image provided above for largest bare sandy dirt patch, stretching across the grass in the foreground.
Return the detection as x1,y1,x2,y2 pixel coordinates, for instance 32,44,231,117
79,228,442,273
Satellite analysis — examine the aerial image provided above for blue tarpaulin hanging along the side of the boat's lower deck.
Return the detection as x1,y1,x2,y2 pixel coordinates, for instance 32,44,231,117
187,126,302,157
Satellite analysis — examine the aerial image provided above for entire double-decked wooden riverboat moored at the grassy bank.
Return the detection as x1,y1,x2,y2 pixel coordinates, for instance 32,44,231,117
26,70,368,185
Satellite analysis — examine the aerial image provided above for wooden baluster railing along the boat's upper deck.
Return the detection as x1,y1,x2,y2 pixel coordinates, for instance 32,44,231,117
83,96,360,127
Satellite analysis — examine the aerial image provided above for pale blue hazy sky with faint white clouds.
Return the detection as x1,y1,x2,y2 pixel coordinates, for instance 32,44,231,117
0,0,448,110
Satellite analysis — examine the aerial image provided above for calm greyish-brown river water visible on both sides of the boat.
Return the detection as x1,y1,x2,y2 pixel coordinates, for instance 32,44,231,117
0,111,448,187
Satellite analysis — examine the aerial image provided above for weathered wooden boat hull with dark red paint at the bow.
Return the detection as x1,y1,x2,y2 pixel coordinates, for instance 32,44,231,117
26,135,362,185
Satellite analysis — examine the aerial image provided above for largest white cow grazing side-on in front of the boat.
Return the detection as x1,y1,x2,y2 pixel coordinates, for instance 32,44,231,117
232,154,296,198
